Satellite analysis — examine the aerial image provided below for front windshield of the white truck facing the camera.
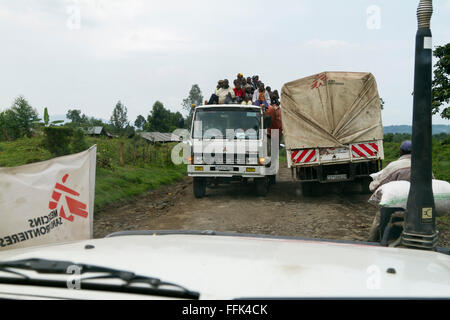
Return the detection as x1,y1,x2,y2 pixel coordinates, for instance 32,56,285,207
193,108,261,140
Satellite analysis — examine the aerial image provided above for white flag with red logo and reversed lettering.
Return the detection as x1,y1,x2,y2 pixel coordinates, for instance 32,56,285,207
0,145,97,250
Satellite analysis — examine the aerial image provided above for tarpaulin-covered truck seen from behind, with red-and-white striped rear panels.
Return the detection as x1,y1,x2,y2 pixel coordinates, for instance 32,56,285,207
281,72,384,195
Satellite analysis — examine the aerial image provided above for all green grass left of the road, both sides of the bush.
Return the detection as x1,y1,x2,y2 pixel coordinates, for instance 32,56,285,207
0,136,186,212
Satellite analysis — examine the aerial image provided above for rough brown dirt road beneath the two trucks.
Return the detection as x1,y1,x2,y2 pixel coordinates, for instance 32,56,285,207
94,165,448,245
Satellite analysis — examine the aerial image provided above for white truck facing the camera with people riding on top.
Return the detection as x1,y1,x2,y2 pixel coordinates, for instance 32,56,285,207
187,104,278,198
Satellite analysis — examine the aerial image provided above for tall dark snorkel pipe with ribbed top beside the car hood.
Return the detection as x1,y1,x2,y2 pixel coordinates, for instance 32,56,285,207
402,0,438,249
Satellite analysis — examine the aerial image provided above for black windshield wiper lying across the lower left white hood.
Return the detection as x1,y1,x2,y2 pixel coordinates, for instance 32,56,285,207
0,258,200,299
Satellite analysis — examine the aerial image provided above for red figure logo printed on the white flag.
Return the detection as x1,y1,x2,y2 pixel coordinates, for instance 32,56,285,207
48,174,88,222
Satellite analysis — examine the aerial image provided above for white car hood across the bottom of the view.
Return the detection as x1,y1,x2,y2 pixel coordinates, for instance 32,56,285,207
0,234,450,299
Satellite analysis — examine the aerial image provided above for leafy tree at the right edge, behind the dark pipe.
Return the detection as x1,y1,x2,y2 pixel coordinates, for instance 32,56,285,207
432,43,450,119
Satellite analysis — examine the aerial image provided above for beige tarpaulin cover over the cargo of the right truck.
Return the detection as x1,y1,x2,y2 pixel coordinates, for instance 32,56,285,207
281,72,383,149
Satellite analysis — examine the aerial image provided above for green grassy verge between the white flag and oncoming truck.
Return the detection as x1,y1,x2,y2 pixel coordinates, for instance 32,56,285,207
87,137,186,211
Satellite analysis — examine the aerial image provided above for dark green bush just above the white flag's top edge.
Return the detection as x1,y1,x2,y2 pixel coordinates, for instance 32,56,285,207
43,127,73,157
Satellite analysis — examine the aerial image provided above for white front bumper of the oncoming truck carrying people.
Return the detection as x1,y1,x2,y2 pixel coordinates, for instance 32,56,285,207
187,164,266,178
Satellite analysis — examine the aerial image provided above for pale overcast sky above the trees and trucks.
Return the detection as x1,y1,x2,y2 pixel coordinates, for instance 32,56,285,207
0,0,450,125
